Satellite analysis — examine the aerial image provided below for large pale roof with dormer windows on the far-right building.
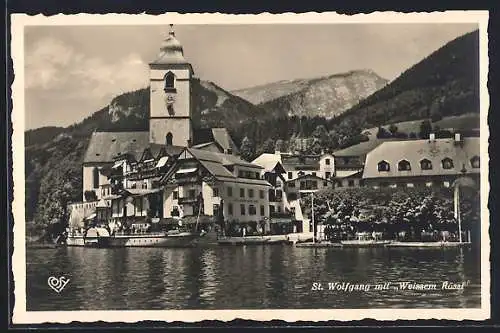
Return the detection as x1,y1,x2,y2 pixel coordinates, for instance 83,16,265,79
363,137,480,178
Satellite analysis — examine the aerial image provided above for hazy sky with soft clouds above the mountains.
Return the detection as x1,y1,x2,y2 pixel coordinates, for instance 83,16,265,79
24,23,477,129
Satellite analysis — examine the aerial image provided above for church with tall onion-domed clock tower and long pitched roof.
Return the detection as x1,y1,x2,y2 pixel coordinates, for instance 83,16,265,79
82,25,238,201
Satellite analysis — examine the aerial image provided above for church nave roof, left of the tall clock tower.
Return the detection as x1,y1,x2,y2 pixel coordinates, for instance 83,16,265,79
83,131,149,163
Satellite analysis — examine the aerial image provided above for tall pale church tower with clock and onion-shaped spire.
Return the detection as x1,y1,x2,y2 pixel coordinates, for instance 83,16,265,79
149,25,194,147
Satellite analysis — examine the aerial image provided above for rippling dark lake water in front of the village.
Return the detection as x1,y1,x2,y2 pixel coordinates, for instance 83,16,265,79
26,245,481,311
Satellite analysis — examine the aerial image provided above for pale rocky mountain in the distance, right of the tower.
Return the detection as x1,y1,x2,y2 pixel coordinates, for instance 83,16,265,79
232,70,387,118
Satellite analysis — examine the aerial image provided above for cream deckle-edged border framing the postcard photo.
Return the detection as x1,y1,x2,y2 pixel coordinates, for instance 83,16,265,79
7,11,491,324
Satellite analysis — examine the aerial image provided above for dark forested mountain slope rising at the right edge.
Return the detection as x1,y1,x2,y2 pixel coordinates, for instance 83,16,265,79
338,31,479,128
